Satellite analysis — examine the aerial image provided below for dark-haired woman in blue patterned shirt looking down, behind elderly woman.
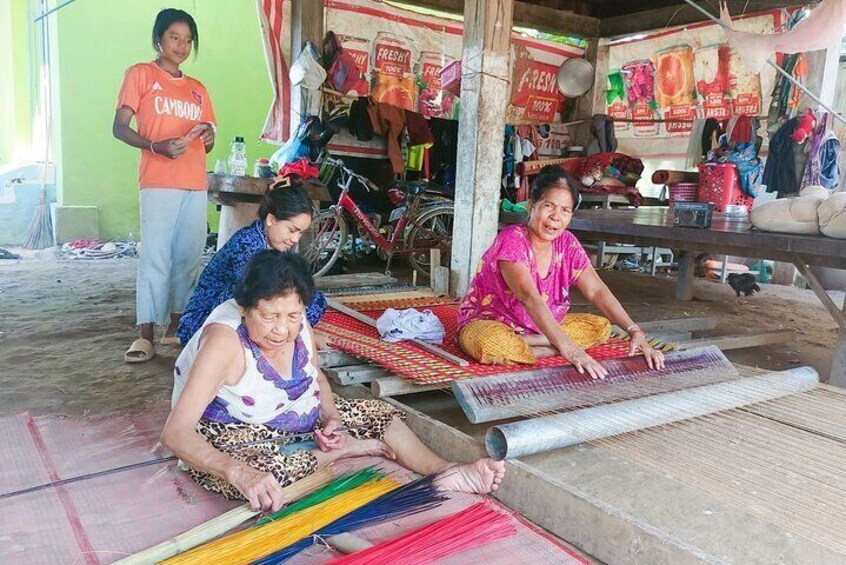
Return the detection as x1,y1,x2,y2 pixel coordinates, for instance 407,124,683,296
176,175,326,345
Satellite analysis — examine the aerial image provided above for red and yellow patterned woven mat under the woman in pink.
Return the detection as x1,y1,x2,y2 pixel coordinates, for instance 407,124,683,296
315,296,629,384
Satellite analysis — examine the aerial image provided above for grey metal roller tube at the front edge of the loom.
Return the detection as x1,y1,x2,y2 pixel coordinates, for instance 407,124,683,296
485,367,819,460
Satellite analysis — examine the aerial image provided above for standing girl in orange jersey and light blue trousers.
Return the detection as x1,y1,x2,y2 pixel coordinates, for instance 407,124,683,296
112,9,215,363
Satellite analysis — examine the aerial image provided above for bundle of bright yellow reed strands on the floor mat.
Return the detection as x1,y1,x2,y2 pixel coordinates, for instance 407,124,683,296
163,478,399,565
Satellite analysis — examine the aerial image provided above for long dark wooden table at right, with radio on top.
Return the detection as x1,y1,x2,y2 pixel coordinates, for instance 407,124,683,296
569,207,846,386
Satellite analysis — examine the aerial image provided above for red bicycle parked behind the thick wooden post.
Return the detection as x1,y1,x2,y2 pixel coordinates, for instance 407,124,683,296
300,157,454,277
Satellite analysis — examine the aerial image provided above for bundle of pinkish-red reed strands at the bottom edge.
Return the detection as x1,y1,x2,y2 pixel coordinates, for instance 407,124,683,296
329,502,517,565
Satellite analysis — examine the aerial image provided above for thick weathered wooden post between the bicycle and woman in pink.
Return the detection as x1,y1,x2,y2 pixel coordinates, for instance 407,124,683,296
450,0,514,296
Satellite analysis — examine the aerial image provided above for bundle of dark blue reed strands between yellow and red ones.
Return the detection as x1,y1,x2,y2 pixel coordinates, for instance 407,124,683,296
253,475,448,565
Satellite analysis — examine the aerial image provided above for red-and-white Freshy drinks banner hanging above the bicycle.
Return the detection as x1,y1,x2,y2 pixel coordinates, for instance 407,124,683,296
257,0,584,148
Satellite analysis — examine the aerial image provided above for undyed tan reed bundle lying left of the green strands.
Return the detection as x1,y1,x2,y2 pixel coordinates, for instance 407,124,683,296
115,468,333,565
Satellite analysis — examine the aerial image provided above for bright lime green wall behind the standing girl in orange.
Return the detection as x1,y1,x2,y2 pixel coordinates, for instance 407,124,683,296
57,0,274,238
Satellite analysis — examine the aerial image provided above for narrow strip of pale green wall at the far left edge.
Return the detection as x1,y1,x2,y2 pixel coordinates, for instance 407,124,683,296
0,0,32,166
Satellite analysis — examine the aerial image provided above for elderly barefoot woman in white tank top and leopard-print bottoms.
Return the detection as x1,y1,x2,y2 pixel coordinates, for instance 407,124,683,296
161,250,505,511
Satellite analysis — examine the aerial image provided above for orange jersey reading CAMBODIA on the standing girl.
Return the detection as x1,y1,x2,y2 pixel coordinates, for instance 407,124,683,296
117,63,216,190
